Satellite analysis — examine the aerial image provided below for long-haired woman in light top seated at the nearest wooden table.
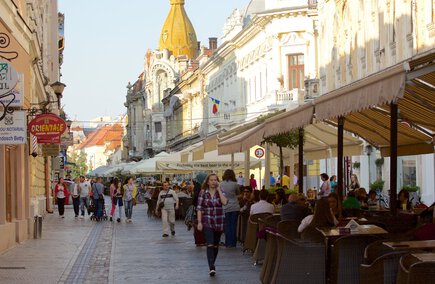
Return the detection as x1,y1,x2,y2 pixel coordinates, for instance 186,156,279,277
298,198,338,242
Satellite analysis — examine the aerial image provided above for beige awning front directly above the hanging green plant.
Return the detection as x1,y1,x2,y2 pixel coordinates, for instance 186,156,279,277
264,102,314,137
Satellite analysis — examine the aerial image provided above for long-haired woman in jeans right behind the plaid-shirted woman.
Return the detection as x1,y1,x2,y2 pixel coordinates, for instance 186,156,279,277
220,169,240,248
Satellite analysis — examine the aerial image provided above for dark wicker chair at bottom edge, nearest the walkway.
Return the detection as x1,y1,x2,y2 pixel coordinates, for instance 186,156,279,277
270,234,325,284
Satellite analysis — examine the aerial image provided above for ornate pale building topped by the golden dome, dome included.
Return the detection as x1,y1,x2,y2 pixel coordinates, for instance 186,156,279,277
125,0,198,160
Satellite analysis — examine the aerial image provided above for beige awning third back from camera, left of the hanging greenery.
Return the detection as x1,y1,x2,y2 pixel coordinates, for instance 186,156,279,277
218,123,264,155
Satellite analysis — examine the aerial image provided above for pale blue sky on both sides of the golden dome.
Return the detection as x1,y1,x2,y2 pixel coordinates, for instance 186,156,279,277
58,0,250,122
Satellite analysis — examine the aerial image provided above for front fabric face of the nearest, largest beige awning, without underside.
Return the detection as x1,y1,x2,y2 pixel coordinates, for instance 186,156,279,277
314,64,406,120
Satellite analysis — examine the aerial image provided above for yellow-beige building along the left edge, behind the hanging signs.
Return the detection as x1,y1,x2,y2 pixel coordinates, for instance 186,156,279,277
0,0,59,251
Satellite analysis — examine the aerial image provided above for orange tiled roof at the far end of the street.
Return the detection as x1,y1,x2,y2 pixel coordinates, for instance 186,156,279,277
77,124,124,150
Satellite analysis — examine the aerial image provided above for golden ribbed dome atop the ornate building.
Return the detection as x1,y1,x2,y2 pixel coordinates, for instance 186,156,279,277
159,0,197,58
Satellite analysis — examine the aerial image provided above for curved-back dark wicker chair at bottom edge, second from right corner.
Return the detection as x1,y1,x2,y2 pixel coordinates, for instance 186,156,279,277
360,251,407,284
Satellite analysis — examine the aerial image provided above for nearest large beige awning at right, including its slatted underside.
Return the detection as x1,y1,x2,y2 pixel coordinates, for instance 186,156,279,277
314,56,435,157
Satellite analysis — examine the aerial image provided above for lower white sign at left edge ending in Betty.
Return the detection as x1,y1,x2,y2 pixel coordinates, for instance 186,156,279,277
0,111,27,145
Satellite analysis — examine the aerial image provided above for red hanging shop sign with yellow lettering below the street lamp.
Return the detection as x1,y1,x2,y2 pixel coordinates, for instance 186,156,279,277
28,113,67,144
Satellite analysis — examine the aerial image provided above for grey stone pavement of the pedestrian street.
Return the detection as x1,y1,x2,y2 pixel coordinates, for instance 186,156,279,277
0,201,261,284
